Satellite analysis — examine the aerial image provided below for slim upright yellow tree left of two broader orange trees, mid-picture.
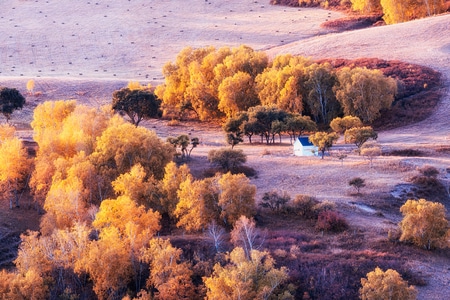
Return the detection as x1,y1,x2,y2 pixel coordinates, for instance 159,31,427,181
161,162,190,218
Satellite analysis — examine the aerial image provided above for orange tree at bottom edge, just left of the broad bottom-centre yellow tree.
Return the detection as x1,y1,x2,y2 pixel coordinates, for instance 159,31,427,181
141,238,195,300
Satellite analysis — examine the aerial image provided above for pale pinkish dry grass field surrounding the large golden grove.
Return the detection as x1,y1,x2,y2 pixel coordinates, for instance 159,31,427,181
0,0,450,299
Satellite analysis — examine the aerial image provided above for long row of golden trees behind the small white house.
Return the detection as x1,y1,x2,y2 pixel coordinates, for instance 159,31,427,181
155,45,397,125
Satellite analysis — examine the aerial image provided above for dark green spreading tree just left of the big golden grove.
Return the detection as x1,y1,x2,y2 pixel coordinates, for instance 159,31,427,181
112,87,162,126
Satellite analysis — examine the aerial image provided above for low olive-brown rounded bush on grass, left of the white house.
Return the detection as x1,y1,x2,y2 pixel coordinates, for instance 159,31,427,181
208,148,247,172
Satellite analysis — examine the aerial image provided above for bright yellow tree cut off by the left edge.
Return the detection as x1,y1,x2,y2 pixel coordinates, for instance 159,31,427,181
0,134,32,209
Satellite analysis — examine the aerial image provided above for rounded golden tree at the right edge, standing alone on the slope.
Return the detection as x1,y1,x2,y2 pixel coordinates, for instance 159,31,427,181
400,199,450,250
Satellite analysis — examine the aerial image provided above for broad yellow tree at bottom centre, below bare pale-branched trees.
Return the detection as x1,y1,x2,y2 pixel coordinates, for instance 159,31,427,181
203,247,288,300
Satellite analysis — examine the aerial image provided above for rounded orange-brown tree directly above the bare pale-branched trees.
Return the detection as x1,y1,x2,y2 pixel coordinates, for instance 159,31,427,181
218,172,256,226
